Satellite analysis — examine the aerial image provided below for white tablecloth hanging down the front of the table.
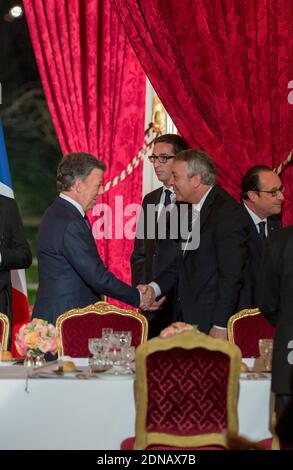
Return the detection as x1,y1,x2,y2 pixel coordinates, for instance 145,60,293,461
0,366,270,450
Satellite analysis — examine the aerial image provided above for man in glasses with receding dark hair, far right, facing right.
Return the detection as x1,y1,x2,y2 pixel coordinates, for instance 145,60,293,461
241,165,284,307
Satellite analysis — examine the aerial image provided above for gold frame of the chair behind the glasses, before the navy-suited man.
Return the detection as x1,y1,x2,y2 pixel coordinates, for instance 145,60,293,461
56,302,148,356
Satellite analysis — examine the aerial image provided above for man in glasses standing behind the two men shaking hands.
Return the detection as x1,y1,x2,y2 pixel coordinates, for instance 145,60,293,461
131,134,188,338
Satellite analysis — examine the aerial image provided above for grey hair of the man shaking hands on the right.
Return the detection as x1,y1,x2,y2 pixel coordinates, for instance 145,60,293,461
174,149,217,186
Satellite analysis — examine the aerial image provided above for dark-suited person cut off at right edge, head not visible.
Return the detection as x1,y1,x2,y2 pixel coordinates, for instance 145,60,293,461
257,226,293,417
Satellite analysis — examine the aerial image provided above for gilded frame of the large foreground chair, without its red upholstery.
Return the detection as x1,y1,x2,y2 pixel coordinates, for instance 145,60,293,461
134,331,241,450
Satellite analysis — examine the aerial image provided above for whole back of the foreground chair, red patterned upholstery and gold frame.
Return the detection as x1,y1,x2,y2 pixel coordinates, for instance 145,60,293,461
134,331,241,449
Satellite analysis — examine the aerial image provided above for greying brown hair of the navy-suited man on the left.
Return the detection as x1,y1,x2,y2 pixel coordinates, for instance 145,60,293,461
56,152,106,192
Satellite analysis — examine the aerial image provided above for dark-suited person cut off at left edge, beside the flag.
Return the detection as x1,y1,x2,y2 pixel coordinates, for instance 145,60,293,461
0,195,32,330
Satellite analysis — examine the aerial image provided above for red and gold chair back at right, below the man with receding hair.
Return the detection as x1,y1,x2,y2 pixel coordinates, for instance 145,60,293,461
228,308,275,357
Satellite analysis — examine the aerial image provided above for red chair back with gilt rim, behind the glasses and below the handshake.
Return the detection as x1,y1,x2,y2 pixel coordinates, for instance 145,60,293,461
56,302,148,357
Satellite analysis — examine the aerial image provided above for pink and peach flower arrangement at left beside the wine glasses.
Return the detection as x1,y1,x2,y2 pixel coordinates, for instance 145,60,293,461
15,318,58,356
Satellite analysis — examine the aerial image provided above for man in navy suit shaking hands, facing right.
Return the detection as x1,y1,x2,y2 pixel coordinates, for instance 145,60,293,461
33,153,151,323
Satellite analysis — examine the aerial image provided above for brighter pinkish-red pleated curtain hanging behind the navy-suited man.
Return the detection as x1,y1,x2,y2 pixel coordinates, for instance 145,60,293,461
23,0,145,294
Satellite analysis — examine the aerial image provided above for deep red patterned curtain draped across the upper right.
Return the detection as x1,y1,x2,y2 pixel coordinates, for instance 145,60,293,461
112,0,293,224
